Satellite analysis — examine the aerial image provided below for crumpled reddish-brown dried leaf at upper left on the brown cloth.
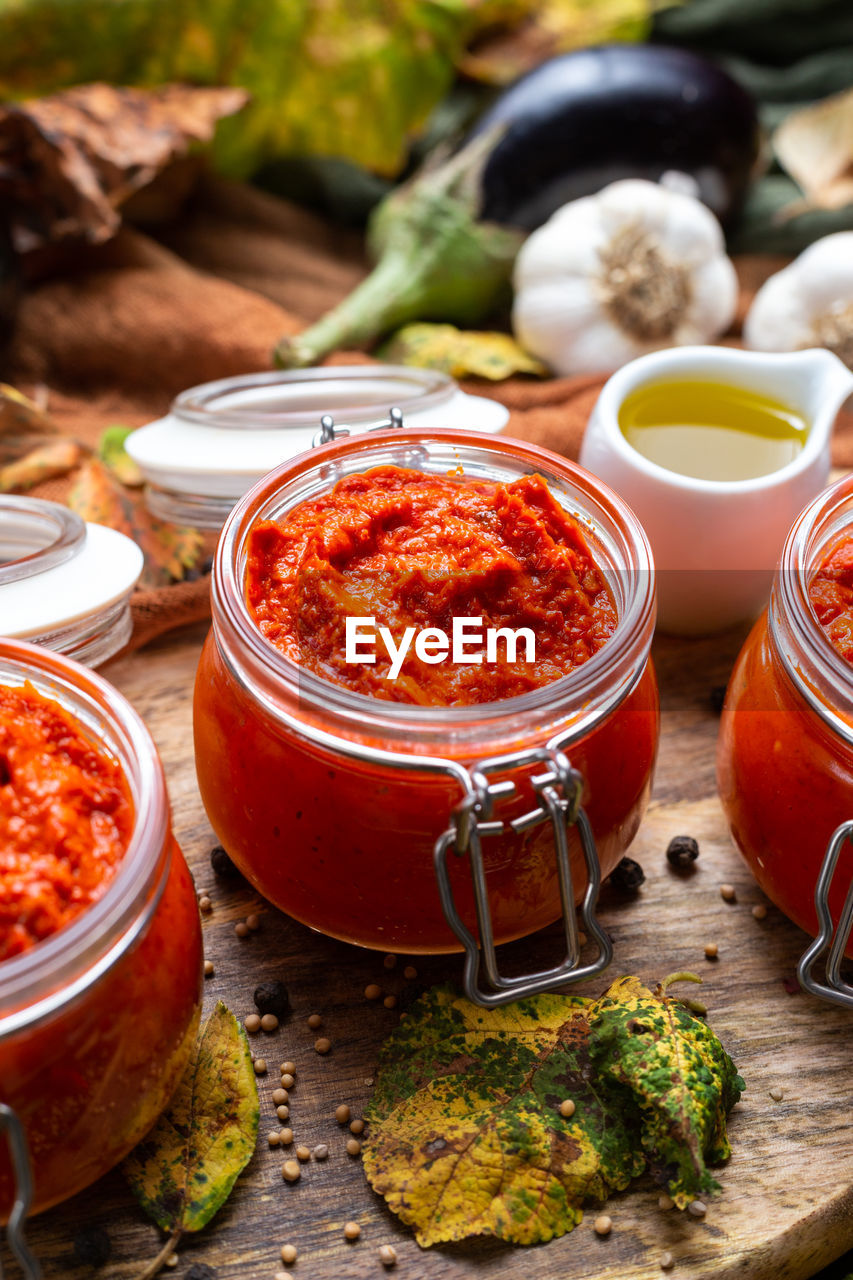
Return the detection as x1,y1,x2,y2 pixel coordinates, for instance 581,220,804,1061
0,83,248,252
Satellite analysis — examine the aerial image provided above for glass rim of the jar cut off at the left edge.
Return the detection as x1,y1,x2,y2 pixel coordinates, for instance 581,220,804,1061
0,639,170,1041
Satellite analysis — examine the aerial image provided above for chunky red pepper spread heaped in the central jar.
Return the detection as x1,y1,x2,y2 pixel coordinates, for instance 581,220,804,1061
246,467,617,707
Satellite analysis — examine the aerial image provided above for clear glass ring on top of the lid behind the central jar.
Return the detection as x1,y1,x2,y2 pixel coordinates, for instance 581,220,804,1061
172,364,459,430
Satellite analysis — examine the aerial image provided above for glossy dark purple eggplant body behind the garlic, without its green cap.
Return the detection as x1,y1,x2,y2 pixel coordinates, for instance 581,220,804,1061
471,45,760,230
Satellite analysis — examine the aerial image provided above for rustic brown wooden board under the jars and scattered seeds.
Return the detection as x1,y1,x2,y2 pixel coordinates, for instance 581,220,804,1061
6,614,853,1280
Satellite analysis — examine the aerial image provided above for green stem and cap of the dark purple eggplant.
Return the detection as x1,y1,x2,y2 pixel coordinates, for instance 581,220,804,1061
274,133,524,369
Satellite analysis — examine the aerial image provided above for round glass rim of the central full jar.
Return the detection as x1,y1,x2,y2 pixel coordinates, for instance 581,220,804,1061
211,426,654,742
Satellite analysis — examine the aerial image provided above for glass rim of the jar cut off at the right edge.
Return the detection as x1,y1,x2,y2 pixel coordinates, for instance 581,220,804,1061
770,475,853,745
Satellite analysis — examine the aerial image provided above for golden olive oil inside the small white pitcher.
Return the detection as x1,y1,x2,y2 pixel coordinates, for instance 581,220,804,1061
619,381,809,480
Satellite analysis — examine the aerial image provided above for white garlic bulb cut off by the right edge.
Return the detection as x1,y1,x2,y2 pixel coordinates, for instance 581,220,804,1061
743,232,853,369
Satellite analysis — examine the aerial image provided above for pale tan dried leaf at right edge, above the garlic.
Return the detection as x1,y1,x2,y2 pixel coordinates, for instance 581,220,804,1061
772,88,853,216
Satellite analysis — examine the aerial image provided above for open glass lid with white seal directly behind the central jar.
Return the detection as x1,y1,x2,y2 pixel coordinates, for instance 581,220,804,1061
126,365,510,530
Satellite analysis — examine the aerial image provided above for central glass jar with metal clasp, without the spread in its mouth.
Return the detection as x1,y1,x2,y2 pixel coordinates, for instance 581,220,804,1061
195,428,658,1002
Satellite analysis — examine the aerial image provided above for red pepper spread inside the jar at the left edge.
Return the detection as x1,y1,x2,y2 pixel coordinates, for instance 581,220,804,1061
0,685,133,960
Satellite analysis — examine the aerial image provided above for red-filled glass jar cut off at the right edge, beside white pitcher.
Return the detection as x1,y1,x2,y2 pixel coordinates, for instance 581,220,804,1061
717,476,853,974
